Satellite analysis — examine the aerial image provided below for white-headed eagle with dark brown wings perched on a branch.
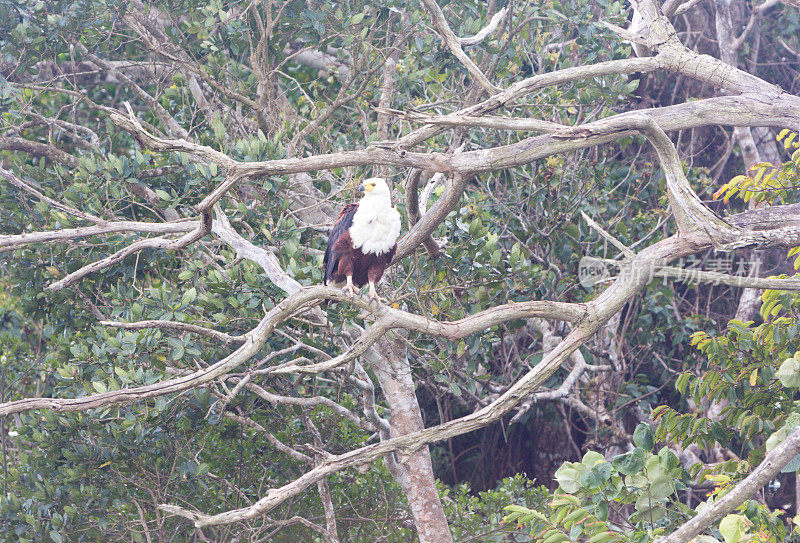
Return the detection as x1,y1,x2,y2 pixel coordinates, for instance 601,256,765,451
322,177,400,304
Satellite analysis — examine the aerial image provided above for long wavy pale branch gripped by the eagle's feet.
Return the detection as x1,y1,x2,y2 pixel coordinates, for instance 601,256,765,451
0,286,590,416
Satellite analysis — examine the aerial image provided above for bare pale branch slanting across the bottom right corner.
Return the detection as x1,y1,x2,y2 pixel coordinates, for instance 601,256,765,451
656,430,800,543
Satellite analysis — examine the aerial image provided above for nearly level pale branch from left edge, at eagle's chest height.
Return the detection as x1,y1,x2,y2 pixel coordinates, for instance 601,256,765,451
0,221,200,252
